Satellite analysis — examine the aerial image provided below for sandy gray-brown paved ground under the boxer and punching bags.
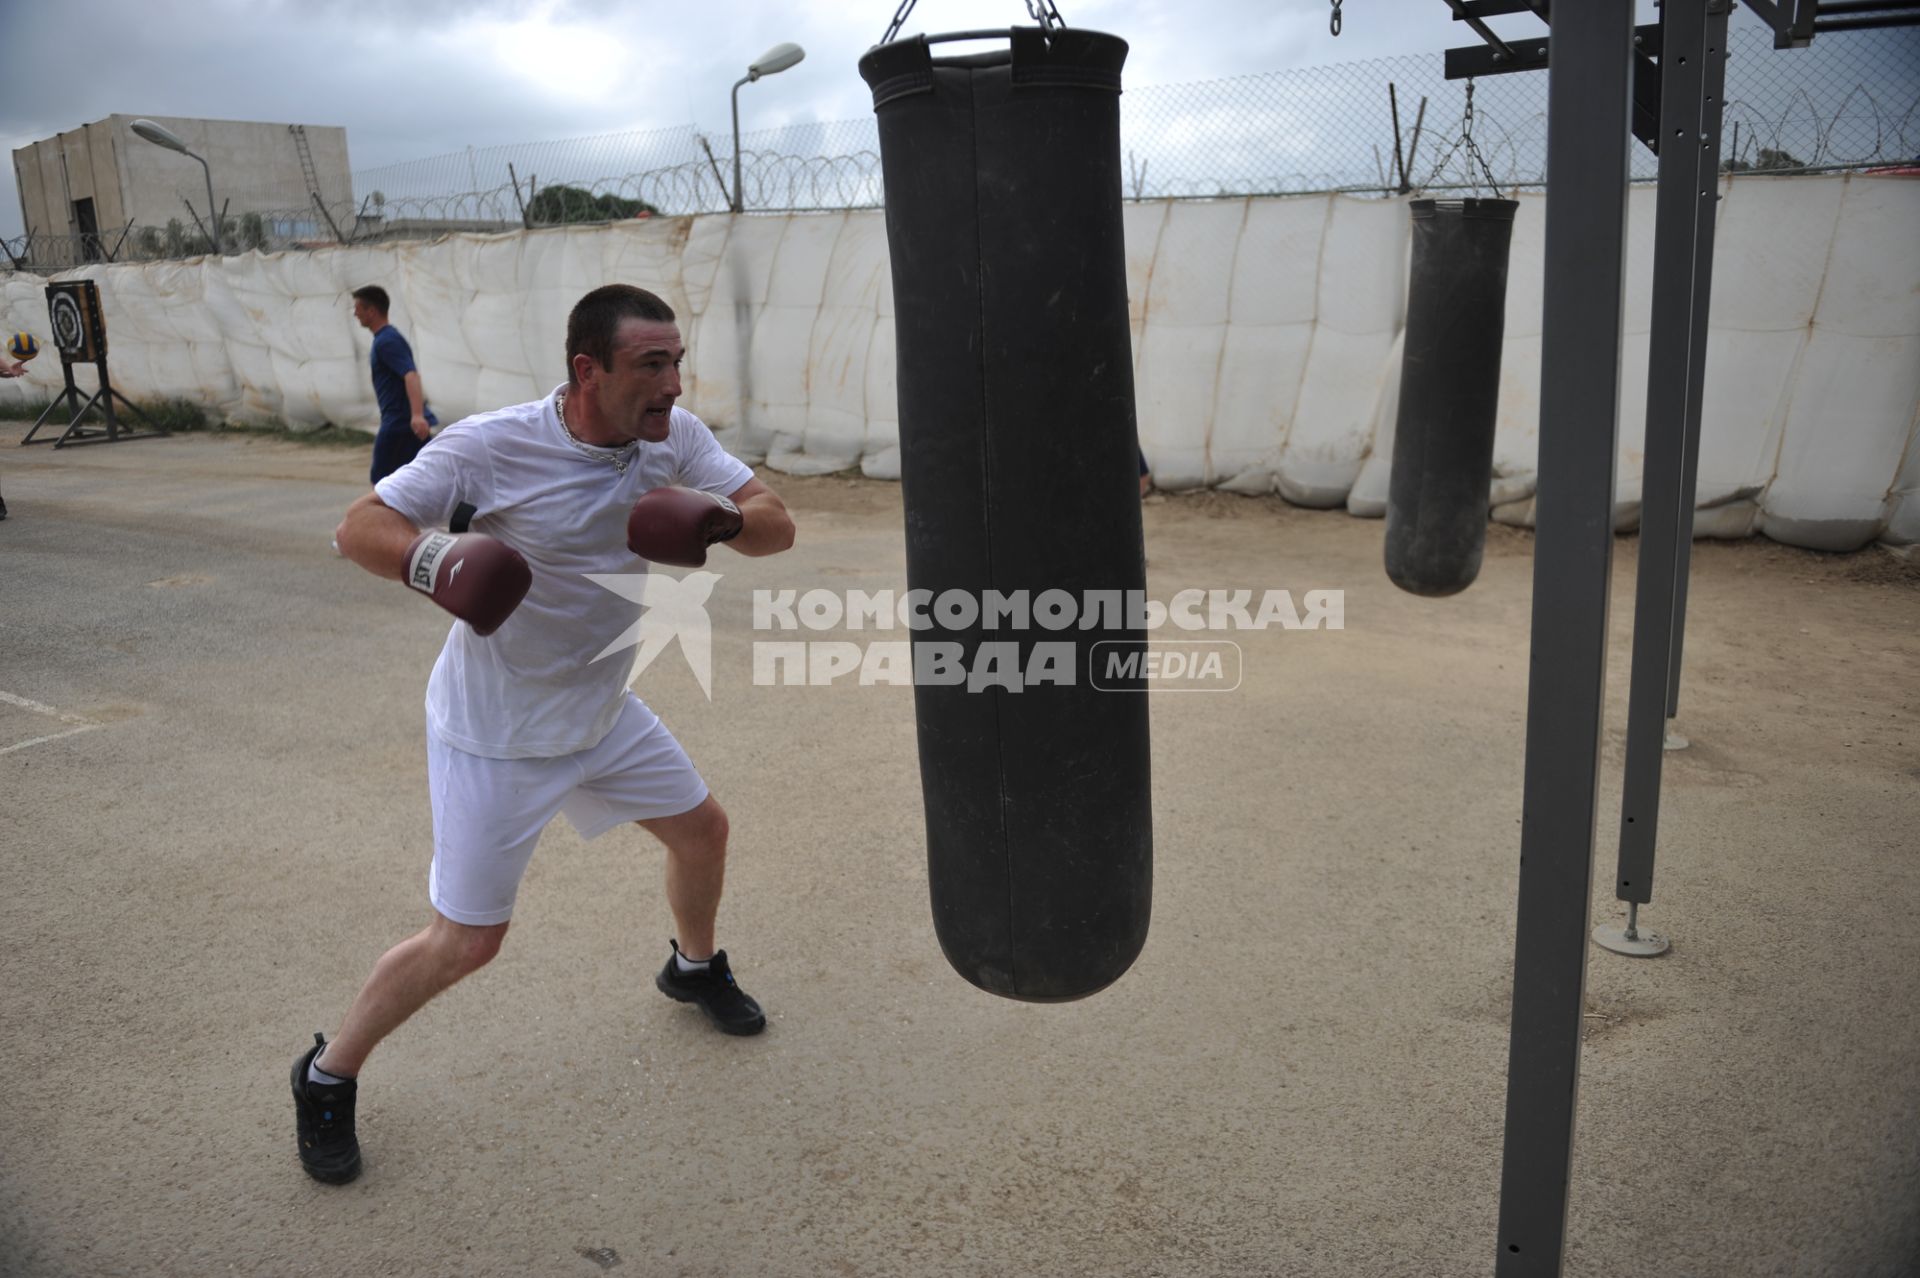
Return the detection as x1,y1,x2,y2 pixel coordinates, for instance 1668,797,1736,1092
0,426,1920,1278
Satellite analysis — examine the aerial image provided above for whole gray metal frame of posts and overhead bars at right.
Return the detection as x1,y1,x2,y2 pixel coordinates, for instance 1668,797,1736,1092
1444,0,1920,1278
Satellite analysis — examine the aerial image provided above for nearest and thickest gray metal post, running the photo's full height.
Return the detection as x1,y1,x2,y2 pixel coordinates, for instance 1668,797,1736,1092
1496,0,1634,1278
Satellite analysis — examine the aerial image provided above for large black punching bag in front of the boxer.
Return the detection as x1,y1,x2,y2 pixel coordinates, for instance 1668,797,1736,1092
860,29,1152,1002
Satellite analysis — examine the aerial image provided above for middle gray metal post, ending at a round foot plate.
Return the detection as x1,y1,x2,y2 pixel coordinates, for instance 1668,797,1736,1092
1601,0,1726,917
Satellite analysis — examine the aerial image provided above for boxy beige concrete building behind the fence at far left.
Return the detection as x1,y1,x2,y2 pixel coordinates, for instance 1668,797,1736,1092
13,115,353,261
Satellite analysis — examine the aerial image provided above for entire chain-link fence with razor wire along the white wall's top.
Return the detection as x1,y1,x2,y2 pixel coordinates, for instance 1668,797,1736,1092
6,25,1920,271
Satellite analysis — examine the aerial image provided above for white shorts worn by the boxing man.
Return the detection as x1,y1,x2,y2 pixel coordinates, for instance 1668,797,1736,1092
426,693,707,927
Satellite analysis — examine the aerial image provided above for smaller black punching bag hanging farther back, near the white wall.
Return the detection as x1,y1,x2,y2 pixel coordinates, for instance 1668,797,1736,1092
1386,200,1519,595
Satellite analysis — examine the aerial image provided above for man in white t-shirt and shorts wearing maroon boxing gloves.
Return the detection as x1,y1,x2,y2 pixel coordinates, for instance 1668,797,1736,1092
292,284,793,1184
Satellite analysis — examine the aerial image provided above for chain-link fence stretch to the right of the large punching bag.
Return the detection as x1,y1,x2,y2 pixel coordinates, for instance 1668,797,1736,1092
1121,27,1920,200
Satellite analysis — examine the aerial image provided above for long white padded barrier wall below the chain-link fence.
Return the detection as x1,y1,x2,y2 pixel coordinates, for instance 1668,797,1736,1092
11,177,1920,551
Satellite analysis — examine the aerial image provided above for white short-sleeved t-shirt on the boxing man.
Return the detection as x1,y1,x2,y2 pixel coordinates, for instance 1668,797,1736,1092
374,388,753,758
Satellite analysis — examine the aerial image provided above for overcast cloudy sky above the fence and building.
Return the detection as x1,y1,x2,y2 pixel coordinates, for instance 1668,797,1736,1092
0,0,1681,236
